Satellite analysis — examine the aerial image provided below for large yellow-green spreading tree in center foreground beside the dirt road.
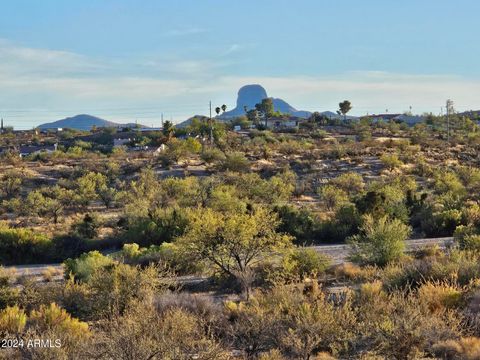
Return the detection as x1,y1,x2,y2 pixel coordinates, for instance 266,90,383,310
177,207,292,298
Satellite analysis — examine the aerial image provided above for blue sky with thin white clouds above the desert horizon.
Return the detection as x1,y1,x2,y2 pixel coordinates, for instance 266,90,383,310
0,0,480,128
